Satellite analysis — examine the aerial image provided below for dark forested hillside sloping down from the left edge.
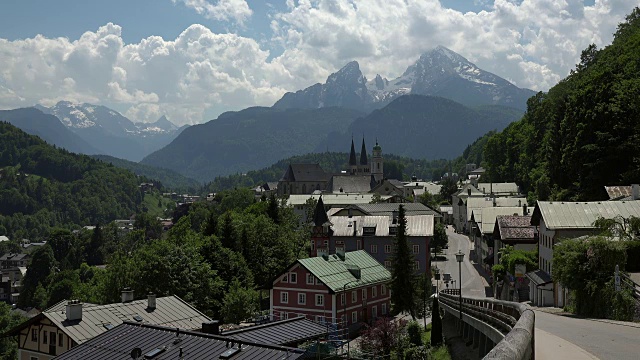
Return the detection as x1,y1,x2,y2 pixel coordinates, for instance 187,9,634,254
0,122,146,240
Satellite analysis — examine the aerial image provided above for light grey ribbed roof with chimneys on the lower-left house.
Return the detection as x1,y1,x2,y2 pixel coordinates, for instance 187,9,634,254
42,296,211,344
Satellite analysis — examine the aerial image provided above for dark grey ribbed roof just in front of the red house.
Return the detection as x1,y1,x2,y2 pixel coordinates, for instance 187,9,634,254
221,316,327,345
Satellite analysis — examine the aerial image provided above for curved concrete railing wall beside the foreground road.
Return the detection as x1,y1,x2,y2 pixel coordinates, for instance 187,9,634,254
439,293,535,360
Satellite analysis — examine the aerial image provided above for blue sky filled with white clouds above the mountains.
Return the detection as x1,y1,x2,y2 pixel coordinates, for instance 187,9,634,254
0,0,640,125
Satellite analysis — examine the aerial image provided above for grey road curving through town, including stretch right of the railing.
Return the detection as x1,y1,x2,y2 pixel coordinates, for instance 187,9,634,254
440,229,640,360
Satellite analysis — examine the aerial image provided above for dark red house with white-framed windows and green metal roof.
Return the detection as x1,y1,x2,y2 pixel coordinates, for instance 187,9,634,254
270,250,391,330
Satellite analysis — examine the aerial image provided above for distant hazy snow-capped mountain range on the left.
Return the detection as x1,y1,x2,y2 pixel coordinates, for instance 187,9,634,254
35,101,184,161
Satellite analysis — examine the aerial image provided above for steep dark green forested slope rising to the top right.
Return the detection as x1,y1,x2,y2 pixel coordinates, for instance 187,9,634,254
484,8,640,200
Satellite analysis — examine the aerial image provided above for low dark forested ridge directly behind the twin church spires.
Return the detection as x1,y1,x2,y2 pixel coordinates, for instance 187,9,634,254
205,148,455,192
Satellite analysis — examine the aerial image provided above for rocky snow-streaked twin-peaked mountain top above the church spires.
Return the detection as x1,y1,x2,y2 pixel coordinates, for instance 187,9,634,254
274,46,535,110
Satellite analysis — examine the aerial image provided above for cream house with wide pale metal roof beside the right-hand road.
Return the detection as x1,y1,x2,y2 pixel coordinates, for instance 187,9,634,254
527,200,640,307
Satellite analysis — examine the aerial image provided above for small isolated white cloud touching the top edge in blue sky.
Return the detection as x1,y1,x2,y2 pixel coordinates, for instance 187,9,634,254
171,0,253,25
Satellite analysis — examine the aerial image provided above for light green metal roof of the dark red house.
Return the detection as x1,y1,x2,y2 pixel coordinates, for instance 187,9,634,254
298,250,391,292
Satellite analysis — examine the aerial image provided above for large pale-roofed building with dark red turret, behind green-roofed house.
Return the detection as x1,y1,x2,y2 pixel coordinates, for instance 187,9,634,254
310,200,435,273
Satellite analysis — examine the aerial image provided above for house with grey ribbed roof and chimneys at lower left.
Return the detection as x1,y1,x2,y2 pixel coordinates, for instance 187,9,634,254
7,289,211,360
